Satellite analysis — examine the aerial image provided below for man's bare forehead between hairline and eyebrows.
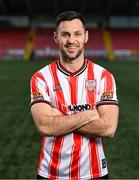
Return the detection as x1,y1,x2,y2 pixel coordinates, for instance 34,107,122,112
58,19,84,32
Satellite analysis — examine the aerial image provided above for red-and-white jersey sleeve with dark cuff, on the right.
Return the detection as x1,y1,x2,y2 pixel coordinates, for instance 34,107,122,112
96,70,119,107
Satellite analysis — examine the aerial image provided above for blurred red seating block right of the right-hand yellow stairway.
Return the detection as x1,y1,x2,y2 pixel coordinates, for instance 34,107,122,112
109,28,139,59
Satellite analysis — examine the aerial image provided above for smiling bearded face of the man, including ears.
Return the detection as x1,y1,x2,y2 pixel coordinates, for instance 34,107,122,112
54,19,88,61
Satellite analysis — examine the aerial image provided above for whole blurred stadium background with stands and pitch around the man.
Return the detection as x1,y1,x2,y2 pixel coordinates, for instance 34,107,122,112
0,0,139,179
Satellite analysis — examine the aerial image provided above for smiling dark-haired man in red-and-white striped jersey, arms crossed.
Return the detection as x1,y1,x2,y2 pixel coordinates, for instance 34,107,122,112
31,11,119,180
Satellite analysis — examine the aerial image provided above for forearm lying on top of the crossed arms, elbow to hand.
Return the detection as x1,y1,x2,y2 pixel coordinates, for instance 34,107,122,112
33,109,95,136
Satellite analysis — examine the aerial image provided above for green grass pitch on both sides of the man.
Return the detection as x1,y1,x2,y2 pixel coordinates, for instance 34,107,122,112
0,60,139,179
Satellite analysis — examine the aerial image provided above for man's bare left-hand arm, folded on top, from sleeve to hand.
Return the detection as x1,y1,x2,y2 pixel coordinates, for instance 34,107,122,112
31,103,99,136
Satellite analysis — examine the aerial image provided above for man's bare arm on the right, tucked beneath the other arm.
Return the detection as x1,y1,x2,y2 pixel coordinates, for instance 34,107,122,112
76,105,119,137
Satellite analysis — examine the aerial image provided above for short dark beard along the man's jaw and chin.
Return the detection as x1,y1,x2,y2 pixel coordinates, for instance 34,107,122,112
60,45,83,61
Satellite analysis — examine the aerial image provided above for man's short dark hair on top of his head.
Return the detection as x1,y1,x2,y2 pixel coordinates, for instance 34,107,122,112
56,11,86,30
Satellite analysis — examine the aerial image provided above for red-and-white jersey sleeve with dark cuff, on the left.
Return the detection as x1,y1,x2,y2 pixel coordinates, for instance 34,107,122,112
30,71,51,106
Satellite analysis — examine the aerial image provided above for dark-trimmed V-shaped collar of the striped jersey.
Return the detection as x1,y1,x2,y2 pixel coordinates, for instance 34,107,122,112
57,59,88,76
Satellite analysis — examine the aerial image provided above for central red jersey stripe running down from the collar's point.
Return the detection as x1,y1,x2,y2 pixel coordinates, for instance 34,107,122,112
69,76,81,179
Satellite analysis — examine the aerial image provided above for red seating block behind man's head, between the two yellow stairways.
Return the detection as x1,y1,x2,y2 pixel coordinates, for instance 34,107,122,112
34,28,106,58
